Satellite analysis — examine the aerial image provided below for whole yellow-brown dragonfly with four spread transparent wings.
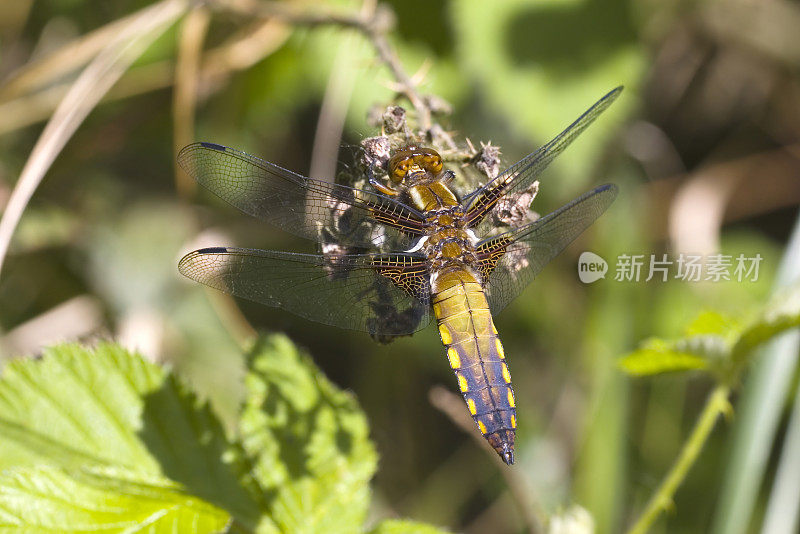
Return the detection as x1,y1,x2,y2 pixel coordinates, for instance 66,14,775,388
178,87,622,465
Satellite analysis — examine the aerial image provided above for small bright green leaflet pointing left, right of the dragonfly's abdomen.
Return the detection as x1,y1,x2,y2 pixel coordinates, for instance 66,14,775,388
619,338,707,376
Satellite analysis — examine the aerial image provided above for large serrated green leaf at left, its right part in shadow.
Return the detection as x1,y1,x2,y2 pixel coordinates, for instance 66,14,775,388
0,344,259,527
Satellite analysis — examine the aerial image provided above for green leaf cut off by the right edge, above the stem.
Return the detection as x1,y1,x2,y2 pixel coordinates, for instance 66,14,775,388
733,284,800,361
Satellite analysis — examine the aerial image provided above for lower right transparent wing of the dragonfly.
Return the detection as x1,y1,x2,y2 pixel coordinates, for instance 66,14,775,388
478,184,617,314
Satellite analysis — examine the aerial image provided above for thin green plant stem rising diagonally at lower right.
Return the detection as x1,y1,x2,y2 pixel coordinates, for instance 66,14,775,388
628,384,730,534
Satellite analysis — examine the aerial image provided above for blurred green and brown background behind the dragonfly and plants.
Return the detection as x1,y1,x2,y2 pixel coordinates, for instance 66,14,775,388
0,0,800,532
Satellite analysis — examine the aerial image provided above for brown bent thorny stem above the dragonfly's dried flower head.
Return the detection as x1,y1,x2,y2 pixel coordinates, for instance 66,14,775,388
211,0,457,150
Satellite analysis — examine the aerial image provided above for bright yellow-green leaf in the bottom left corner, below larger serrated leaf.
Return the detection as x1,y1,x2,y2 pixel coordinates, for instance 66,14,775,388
0,467,230,533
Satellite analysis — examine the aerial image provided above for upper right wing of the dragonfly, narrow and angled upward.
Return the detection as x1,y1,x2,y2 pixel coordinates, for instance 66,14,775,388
464,87,622,230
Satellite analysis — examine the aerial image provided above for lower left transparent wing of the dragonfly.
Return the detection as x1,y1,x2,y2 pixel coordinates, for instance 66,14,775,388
178,247,430,336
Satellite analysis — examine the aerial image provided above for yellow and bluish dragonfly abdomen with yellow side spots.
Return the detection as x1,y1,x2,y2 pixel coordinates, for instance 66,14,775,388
433,269,517,464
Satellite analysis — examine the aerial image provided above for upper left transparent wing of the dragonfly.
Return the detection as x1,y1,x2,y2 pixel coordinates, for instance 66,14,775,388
178,143,423,248
